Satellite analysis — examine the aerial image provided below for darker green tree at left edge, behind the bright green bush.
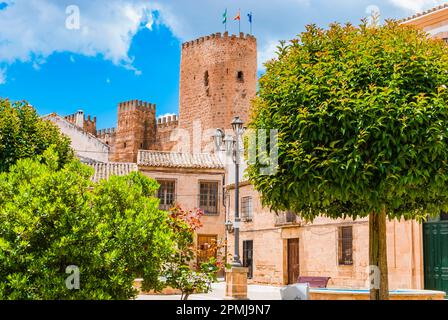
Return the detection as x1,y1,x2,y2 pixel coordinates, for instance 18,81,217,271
0,98,73,172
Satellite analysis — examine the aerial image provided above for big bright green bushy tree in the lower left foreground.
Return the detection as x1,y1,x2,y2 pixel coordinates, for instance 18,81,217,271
0,149,174,300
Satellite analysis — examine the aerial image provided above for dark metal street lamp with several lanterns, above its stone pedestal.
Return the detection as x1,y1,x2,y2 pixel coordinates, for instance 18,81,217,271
214,117,244,267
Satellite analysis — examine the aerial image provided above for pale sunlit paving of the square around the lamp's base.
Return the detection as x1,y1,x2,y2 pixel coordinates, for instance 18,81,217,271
137,282,281,300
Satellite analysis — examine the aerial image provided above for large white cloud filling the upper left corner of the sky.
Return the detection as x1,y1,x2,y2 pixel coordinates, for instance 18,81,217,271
0,0,157,73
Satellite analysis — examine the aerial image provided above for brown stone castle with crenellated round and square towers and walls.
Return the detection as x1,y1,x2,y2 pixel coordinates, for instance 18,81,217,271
66,32,257,158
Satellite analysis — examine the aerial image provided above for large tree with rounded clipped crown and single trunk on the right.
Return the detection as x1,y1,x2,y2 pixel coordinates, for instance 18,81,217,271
248,21,448,299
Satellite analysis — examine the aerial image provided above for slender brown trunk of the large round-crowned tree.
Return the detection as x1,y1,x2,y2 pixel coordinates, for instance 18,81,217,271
369,208,389,300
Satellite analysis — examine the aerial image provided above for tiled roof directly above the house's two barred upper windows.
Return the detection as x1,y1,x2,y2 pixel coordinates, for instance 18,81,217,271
137,150,224,169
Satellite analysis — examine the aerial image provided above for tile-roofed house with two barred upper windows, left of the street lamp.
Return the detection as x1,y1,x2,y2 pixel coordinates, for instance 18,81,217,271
137,150,226,268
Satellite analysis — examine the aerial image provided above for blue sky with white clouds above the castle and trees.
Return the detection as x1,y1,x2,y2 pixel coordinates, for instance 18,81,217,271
0,0,446,128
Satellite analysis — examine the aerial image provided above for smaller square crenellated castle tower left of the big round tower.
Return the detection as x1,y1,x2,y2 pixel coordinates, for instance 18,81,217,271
111,100,156,162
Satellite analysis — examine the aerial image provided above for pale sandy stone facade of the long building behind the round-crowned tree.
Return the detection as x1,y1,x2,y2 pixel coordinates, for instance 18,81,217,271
228,185,424,289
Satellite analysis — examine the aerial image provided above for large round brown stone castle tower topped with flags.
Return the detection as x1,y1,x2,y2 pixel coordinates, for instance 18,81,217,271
179,32,257,152
